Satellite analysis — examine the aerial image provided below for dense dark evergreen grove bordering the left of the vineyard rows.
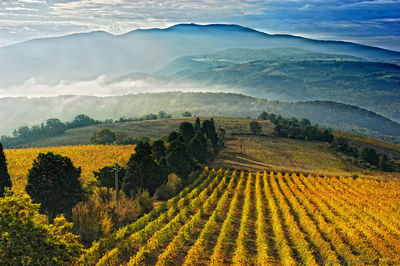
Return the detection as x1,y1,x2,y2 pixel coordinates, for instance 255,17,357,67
115,118,223,196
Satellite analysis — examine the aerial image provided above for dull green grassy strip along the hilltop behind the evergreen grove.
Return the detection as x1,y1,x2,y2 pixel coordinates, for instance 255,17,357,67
29,117,273,147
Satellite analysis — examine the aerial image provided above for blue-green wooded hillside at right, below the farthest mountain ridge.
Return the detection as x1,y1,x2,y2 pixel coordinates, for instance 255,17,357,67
158,48,400,121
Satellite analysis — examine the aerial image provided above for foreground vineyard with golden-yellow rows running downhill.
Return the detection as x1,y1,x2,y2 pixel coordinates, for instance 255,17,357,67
80,168,400,265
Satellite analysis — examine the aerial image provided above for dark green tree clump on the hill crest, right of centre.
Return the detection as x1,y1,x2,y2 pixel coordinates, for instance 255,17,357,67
258,112,333,143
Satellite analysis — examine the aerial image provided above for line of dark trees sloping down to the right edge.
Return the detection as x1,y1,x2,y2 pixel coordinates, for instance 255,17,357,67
331,137,400,172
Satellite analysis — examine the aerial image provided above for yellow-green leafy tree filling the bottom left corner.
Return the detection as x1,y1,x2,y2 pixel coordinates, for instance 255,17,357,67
0,191,82,265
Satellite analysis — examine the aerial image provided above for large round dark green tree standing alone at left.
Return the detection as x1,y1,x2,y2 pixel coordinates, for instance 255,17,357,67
26,152,83,221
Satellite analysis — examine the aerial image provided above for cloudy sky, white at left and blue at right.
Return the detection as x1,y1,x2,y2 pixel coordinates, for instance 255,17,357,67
0,0,400,51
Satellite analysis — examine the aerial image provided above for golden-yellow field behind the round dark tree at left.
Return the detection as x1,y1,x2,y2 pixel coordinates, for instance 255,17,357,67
5,145,135,192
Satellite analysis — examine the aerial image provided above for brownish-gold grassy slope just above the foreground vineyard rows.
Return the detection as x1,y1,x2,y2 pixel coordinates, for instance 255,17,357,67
211,135,359,175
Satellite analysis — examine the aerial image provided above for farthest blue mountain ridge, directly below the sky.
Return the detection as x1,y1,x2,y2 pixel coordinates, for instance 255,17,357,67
0,24,400,90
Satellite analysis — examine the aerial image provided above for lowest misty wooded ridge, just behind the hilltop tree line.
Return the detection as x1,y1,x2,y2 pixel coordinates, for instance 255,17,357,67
0,92,400,141
